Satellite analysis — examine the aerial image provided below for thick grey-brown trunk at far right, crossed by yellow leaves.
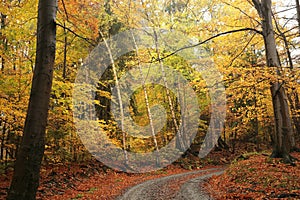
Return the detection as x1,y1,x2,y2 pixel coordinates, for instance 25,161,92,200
252,0,293,162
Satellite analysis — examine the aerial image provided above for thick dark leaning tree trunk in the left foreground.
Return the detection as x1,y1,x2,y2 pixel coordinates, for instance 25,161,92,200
7,0,57,200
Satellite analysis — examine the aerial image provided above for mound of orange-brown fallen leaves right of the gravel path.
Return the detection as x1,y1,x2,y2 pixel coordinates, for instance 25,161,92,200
205,153,300,199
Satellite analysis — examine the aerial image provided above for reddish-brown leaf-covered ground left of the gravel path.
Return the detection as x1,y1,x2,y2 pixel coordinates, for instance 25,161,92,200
0,162,198,200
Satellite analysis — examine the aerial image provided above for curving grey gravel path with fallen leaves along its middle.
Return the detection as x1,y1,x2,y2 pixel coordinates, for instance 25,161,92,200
117,168,223,200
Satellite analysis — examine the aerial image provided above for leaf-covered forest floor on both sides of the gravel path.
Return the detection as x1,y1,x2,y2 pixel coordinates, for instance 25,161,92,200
0,147,300,200
